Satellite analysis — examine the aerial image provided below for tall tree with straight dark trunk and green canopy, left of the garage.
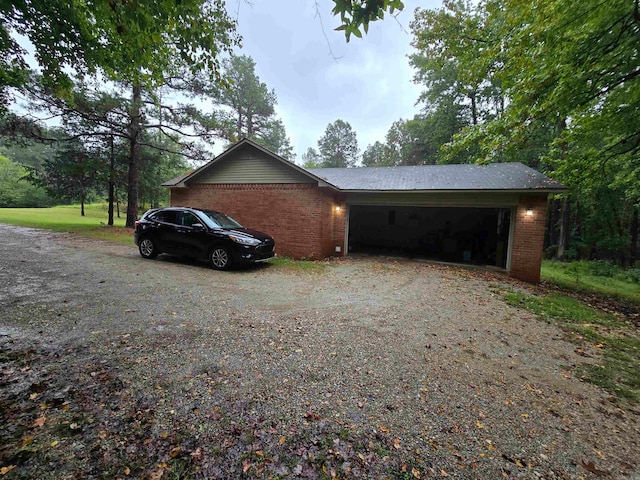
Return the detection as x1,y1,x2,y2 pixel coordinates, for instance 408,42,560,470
0,0,238,227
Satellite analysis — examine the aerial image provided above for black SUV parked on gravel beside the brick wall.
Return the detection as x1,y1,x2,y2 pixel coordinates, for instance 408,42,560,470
134,207,275,270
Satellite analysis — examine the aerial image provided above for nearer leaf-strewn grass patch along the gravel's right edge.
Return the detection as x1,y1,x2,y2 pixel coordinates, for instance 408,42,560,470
504,292,640,403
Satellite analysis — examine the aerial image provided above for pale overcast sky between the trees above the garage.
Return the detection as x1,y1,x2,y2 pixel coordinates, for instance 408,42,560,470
227,0,440,163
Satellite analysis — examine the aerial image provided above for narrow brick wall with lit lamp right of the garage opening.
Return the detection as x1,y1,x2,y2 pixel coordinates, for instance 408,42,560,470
509,195,547,283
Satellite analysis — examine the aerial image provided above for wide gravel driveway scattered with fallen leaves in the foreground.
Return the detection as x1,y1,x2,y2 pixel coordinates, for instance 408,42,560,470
0,226,640,479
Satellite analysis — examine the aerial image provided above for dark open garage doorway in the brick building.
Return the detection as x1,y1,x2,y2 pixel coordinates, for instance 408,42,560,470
348,205,511,268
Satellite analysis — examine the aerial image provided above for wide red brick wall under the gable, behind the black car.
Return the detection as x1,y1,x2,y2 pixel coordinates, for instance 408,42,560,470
171,184,346,259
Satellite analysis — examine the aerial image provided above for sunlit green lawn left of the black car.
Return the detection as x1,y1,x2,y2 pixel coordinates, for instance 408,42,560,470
0,203,133,244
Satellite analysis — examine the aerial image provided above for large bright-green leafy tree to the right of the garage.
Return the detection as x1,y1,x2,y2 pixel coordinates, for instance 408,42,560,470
412,0,640,261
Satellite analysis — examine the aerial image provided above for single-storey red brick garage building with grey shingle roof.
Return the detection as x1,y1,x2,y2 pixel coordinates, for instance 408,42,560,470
164,139,565,282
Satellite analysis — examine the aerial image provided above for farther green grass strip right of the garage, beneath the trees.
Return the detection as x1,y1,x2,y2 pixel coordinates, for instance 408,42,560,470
541,260,640,303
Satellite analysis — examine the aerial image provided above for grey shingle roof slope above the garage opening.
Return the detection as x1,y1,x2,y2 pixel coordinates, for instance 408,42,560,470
307,163,566,191
